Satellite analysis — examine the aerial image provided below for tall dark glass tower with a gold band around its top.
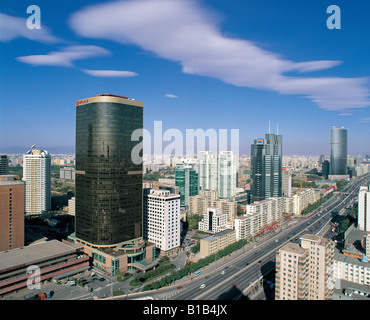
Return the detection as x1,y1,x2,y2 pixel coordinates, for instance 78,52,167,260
75,94,144,247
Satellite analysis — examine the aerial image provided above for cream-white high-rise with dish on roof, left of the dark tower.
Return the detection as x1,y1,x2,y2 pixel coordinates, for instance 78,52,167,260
22,149,51,214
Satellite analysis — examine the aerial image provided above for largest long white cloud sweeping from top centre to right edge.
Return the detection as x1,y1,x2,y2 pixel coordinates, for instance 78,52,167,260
69,0,370,110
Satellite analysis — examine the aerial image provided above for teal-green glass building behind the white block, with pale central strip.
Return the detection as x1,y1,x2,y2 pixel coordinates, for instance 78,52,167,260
175,163,198,207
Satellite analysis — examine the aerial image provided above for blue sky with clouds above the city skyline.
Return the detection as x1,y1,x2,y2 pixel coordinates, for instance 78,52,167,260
0,0,370,155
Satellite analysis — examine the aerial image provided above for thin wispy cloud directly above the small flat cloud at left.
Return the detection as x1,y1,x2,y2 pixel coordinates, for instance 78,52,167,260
16,46,110,67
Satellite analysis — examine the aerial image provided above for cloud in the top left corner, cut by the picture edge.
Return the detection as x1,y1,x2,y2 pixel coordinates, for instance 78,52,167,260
0,13,61,43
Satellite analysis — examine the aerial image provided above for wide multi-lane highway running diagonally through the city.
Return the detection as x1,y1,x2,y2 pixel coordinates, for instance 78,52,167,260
120,175,370,300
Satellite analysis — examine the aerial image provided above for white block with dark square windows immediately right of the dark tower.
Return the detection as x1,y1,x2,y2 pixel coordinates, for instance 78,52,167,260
143,188,181,252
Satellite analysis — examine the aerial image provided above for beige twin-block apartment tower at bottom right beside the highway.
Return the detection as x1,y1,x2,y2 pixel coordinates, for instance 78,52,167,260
275,234,334,300
